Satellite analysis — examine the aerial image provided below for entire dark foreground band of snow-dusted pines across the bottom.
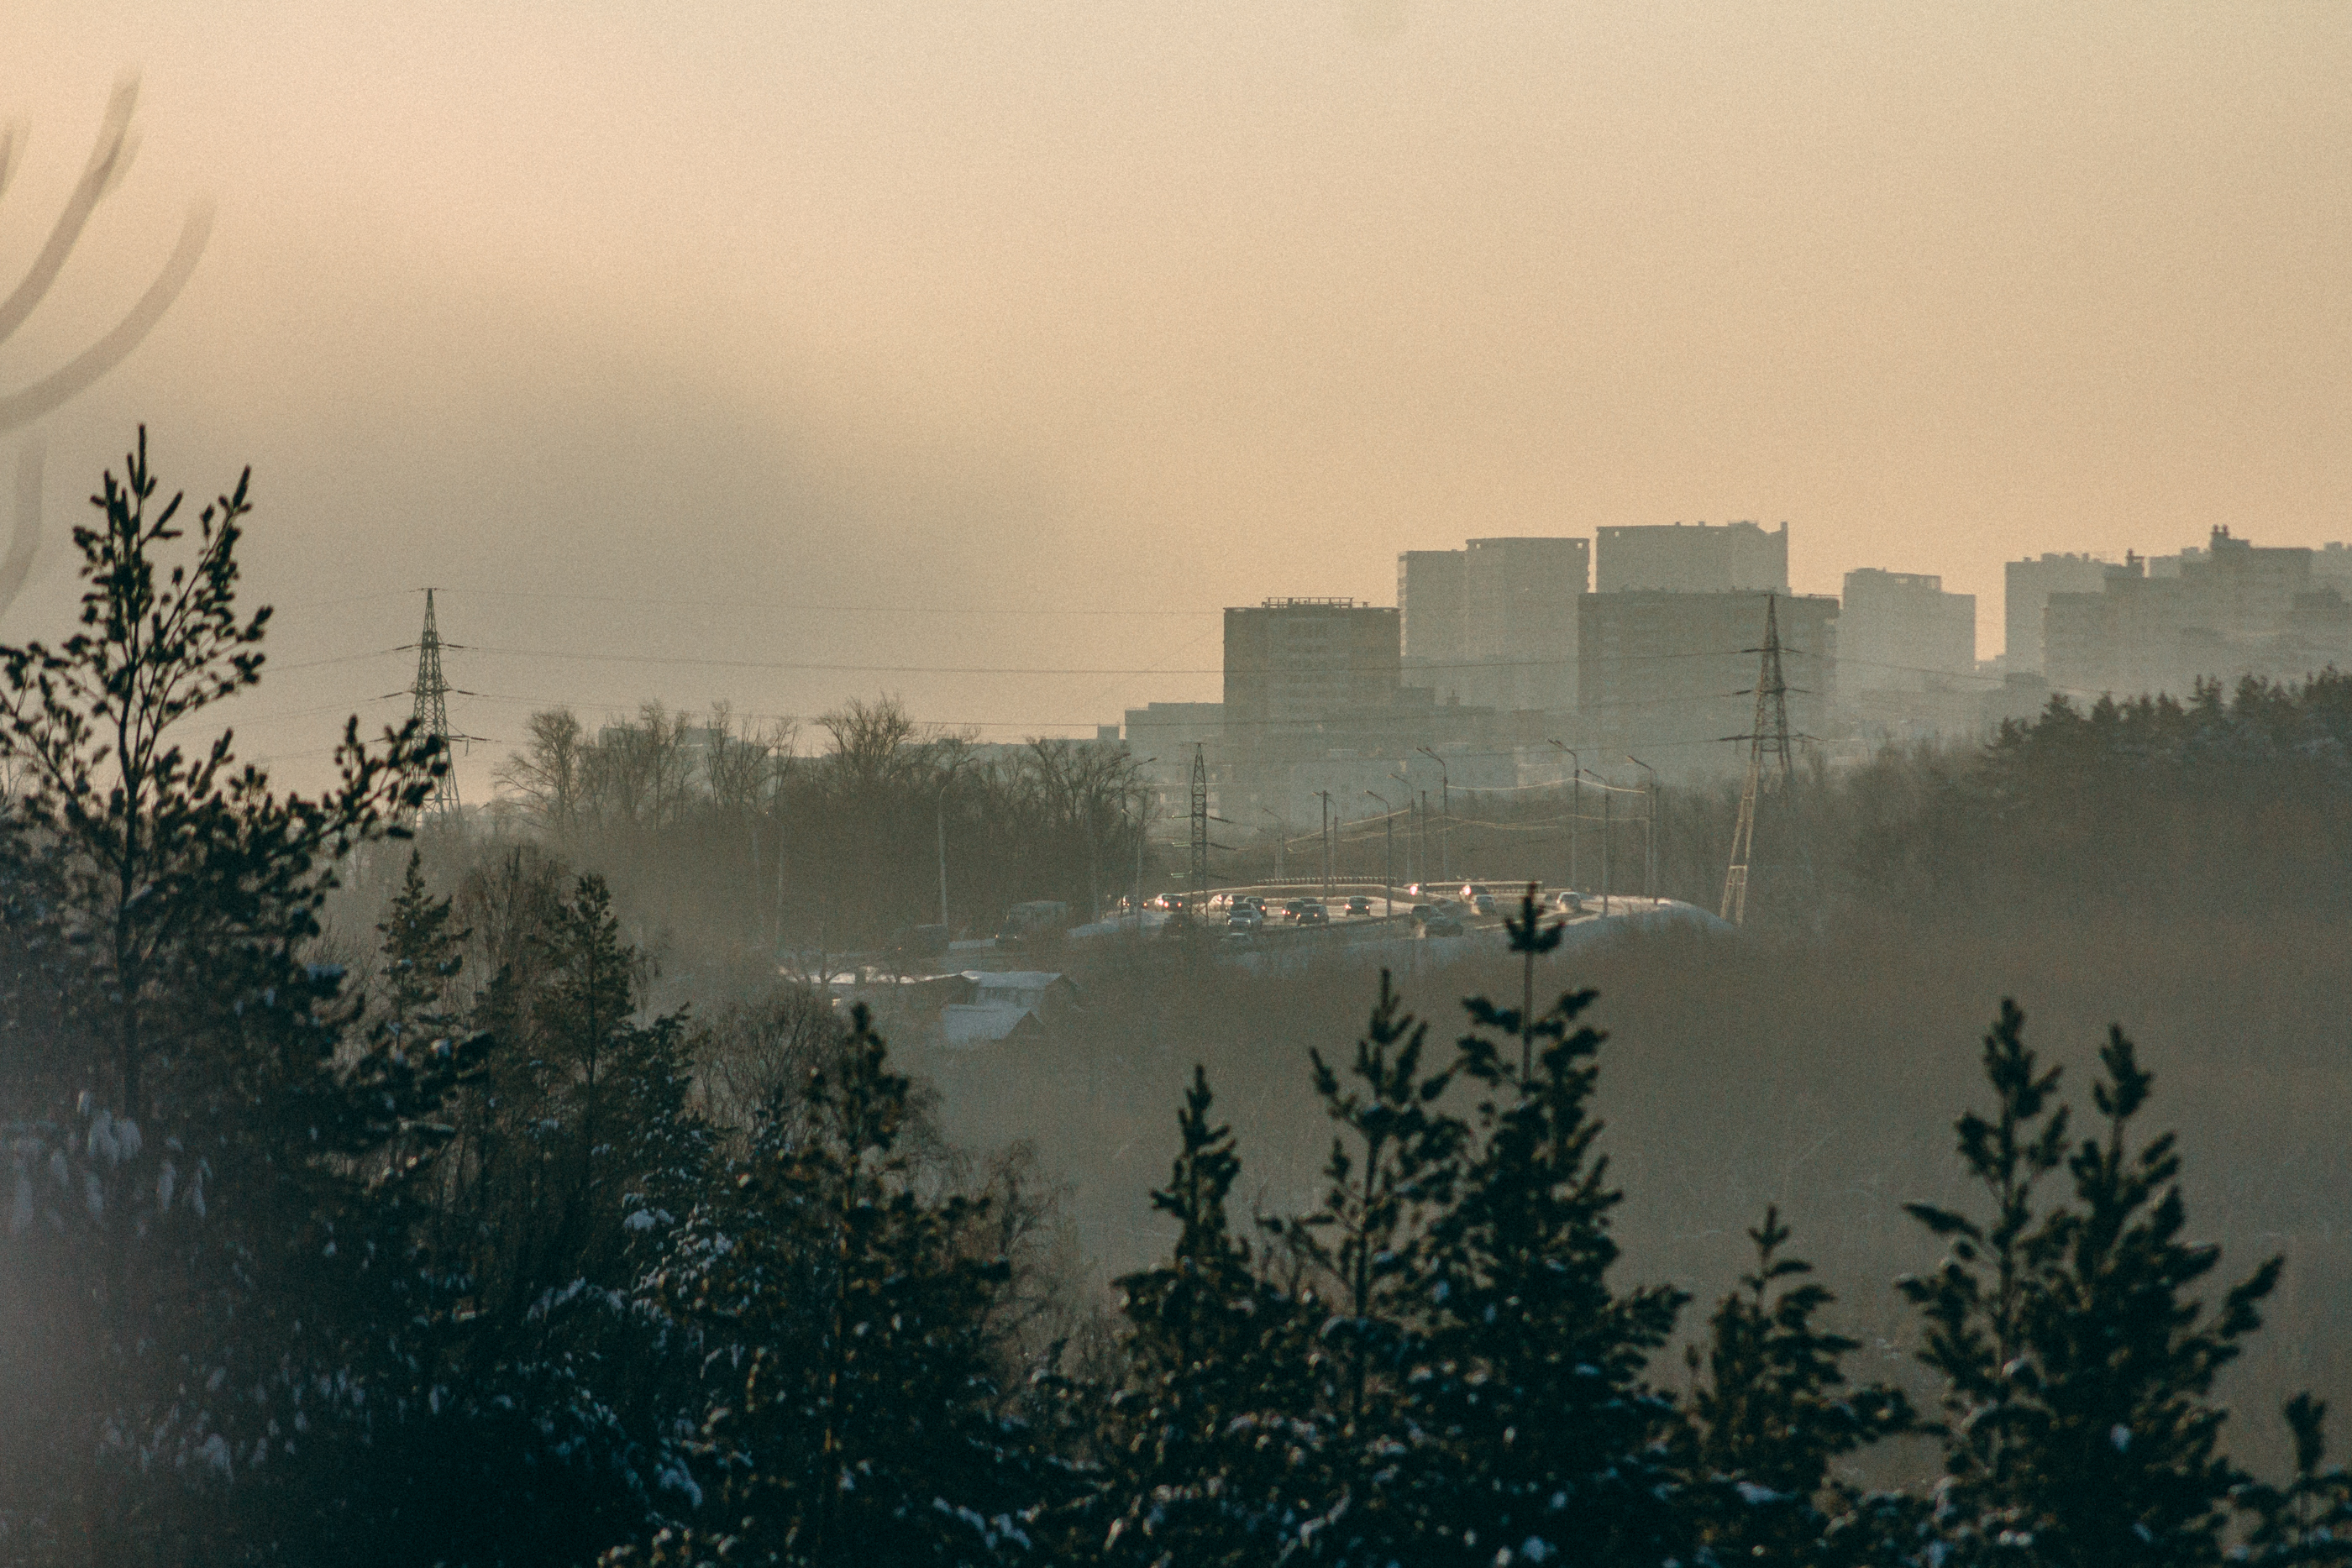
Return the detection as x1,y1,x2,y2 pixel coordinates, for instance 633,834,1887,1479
0,435,2352,1568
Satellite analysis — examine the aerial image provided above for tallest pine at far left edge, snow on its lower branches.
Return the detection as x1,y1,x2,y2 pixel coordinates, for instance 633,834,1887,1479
0,430,473,1561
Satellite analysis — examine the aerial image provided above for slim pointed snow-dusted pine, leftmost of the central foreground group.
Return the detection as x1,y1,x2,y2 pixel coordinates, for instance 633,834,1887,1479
1084,1067,1322,1568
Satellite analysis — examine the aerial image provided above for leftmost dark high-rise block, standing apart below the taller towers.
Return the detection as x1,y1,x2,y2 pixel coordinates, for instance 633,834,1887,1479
1223,600,1402,750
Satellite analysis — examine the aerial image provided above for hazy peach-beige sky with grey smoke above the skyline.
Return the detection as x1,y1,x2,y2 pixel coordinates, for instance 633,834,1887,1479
0,0,2352,797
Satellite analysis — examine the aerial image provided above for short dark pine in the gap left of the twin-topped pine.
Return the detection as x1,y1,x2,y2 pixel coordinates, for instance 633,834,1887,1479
1679,1209,1912,1568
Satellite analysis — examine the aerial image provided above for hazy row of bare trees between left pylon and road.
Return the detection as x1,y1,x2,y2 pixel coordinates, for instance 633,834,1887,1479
501,696,1150,954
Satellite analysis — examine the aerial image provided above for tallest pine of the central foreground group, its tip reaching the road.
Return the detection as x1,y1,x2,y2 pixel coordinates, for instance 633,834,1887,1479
1404,898,1687,1565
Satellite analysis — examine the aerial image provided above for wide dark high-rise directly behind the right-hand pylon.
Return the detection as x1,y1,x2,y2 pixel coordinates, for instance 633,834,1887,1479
1578,590,1837,774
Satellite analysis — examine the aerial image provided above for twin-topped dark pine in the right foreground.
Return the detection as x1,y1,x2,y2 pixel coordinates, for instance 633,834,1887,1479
1903,1001,2281,1565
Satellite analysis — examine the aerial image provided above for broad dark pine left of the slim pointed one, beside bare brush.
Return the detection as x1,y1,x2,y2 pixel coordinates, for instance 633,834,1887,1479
652,1009,1047,1568
